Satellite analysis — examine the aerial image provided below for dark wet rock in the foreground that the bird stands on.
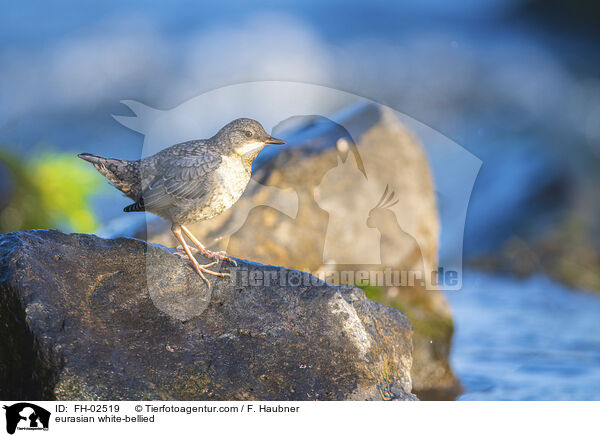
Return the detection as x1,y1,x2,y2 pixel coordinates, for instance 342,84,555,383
0,231,416,400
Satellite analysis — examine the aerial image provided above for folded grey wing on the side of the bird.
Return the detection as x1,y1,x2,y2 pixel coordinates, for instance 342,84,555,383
140,154,221,211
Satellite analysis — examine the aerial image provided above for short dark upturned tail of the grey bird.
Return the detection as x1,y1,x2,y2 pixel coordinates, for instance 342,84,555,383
77,153,141,200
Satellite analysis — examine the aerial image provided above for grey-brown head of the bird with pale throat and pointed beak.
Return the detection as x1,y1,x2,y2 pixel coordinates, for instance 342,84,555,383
216,118,285,157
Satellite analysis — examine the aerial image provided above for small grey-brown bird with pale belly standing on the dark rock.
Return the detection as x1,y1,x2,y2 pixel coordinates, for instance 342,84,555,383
77,118,285,288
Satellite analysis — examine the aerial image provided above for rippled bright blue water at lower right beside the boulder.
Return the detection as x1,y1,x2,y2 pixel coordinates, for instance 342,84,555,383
447,271,600,400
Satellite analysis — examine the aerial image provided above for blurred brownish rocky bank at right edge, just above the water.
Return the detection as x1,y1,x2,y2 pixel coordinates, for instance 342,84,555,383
469,157,600,291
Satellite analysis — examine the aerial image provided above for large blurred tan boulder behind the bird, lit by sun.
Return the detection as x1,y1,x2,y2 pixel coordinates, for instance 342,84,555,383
136,105,460,399
